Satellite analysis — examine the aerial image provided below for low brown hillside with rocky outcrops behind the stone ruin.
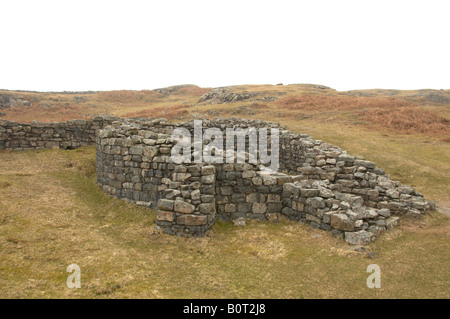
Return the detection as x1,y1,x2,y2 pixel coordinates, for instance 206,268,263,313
0,83,450,140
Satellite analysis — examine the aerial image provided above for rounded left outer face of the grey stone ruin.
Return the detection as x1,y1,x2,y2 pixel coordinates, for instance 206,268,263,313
96,122,175,209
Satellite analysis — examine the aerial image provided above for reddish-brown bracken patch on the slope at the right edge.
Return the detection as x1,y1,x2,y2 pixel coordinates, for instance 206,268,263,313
358,107,450,135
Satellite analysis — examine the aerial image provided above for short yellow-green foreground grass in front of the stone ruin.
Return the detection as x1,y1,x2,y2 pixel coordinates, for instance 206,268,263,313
0,147,450,298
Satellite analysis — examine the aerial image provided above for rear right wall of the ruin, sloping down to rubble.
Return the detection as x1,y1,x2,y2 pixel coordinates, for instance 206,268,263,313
280,132,433,215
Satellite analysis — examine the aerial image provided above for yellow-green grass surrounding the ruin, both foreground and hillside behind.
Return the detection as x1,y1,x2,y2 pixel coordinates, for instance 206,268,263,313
0,86,450,298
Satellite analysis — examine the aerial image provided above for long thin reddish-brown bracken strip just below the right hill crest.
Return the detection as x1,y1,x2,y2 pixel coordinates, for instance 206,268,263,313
275,94,413,111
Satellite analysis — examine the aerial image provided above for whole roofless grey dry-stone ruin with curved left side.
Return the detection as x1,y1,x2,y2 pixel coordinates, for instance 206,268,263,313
97,119,434,245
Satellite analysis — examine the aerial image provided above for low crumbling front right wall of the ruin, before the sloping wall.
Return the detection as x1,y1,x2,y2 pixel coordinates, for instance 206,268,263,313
282,181,420,245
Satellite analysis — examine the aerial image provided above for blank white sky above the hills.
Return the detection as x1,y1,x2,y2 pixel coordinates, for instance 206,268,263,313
0,0,450,91
